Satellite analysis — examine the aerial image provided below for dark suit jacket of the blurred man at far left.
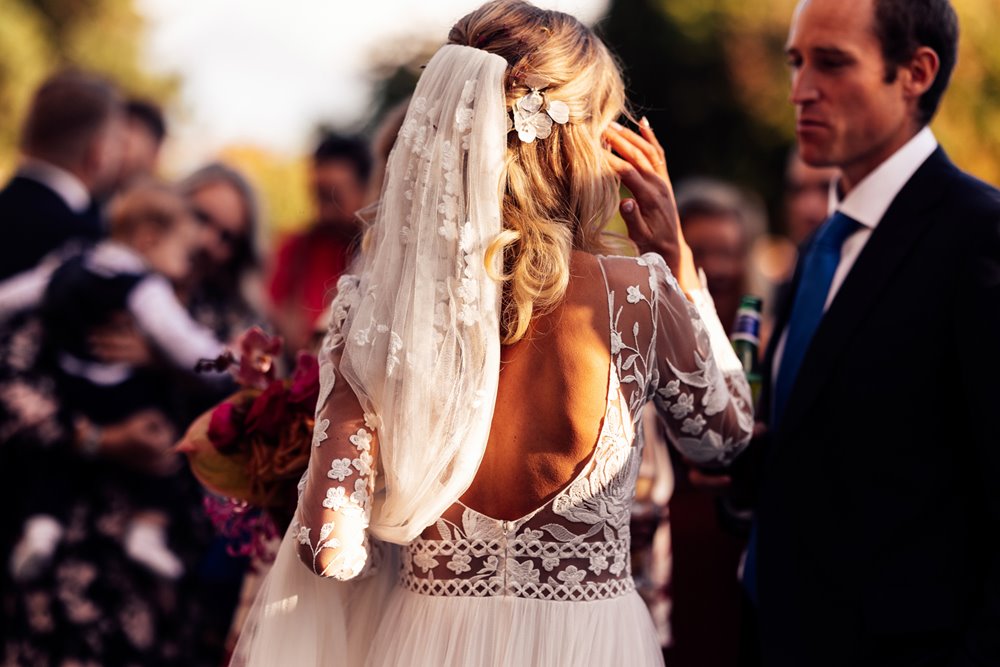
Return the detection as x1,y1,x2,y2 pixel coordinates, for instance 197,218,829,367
0,176,102,280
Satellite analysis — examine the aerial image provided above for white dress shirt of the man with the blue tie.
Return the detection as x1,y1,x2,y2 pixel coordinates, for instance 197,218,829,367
771,127,938,382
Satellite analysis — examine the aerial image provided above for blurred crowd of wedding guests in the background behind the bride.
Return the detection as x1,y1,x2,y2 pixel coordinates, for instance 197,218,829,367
0,71,835,667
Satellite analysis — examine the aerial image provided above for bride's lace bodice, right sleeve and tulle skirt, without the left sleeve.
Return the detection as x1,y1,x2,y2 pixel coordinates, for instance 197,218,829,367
369,256,752,666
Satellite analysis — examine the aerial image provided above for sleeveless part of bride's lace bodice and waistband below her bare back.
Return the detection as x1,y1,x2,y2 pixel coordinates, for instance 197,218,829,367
401,364,640,600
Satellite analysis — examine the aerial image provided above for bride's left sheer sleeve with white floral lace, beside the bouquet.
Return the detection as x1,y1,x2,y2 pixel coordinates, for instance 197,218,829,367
293,318,378,580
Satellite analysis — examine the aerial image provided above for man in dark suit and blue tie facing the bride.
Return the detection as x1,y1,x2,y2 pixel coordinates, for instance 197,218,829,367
745,0,1000,667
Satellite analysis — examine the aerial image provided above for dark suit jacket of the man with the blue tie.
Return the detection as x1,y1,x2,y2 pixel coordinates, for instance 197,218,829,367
757,148,1000,667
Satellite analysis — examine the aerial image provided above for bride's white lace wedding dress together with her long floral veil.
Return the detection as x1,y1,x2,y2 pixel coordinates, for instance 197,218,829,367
234,46,753,667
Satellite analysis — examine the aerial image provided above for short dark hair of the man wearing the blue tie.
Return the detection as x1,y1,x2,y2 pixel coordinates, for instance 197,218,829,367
875,0,958,125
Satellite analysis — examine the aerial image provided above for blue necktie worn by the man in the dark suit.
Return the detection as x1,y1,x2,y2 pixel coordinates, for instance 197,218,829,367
743,211,861,605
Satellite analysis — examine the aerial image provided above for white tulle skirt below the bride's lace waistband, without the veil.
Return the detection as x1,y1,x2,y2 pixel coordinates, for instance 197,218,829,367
366,586,663,667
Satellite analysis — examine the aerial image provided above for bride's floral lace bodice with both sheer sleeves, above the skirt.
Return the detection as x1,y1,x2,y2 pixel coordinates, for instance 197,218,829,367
293,254,753,588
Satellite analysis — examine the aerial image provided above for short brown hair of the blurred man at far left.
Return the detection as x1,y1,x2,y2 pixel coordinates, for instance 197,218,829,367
21,70,122,162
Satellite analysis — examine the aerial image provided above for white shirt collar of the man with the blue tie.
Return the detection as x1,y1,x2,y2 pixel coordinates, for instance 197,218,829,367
830,127,938,229
